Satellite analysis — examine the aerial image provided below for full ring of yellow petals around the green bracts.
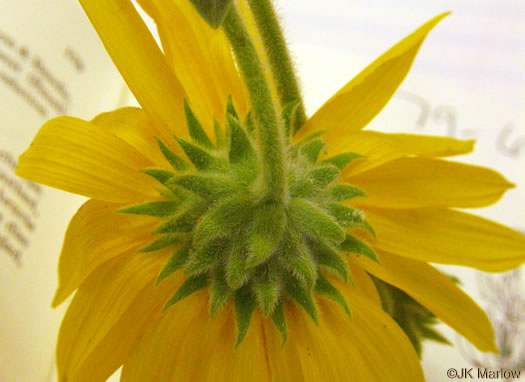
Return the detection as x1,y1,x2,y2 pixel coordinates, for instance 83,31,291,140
17,0,525,382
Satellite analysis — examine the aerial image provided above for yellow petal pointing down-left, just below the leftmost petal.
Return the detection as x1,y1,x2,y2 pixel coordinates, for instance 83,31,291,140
53,200,157,306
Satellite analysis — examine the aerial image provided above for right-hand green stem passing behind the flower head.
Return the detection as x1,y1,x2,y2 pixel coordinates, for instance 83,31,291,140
248,0,306,132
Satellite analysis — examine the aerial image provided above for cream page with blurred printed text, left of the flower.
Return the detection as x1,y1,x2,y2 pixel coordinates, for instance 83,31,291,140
0,0,129,382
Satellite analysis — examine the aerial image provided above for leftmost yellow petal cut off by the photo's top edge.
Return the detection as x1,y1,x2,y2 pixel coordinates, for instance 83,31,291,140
80,0,185,133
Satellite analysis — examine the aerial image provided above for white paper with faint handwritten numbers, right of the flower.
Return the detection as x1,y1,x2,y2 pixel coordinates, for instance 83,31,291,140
278,0,525,381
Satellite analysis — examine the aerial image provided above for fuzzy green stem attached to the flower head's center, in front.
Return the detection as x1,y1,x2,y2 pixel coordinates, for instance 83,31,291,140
222,4,286,203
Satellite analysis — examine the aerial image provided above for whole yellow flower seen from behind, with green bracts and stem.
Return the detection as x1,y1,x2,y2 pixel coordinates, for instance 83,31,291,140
17,0,525,382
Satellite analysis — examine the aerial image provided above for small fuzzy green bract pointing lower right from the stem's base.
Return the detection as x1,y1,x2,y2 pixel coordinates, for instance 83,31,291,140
290,198,346,243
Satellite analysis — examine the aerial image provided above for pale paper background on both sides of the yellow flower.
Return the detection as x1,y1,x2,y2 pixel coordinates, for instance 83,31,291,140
0,0,525,382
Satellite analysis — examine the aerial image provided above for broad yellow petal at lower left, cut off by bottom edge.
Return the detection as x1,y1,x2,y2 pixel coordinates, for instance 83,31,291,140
57,252,176,382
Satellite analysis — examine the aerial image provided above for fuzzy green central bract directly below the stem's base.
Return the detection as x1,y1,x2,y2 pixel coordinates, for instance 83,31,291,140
246,204,286,268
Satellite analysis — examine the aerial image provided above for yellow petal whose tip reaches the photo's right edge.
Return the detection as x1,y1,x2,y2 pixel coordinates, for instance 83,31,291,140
365,207,525,272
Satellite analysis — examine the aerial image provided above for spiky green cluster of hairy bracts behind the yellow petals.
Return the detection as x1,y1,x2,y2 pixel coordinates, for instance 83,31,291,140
126,102,377,343
